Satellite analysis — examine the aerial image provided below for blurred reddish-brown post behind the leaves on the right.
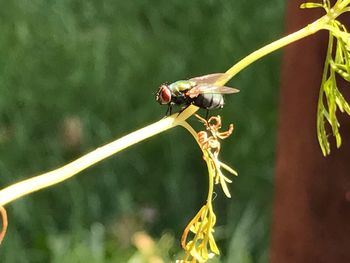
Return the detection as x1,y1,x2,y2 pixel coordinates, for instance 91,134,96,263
270,0,350,263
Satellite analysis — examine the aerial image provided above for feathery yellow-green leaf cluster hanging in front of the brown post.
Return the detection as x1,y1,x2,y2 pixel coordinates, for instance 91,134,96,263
301,0,350,155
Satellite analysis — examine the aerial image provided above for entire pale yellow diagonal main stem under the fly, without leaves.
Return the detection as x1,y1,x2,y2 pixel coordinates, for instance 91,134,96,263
0,9,338,206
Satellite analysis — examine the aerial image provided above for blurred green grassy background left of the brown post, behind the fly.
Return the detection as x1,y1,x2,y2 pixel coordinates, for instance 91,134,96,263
0,0,284,263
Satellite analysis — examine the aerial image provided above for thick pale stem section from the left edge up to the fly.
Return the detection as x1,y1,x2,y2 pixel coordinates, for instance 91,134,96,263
0,106,198,207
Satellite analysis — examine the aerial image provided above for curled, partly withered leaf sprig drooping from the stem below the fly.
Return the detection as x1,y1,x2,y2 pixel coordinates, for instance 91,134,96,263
179,115,237,262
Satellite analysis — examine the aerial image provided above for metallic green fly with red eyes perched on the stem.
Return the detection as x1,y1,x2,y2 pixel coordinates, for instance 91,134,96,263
156,73,239,116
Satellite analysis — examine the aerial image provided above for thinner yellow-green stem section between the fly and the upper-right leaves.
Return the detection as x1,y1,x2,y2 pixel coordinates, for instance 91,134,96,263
215,15,329,86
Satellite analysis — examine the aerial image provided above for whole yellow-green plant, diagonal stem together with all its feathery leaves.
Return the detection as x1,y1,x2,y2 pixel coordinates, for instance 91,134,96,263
0,0,350,262
